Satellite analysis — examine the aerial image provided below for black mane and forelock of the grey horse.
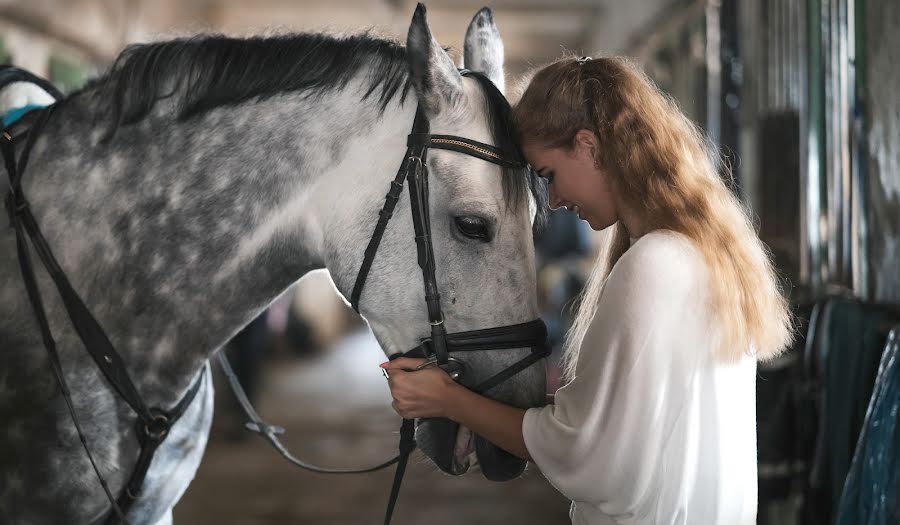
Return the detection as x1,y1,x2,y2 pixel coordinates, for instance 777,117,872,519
70,32,546,225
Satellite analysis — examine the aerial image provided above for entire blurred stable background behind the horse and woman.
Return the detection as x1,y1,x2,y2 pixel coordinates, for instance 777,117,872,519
0,0,900,525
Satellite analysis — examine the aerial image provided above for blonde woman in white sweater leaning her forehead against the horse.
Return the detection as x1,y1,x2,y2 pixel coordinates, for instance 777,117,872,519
382,58,792,525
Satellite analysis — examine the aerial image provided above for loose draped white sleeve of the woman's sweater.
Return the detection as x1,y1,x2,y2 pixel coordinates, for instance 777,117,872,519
523,234,707,516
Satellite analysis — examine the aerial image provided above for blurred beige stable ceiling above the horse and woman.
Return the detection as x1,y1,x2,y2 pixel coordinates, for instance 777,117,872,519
0,0,697,75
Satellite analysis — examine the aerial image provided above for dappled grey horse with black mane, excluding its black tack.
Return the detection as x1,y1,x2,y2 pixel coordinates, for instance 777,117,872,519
0,5,545,524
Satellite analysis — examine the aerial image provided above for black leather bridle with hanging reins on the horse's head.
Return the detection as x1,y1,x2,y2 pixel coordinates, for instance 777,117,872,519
230,70,551,525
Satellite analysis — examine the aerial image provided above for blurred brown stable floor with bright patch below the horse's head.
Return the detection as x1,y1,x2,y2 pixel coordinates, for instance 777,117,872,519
175,331,569,525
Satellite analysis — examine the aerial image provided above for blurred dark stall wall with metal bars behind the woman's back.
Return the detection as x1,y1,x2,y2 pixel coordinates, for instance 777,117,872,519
635,0,900,524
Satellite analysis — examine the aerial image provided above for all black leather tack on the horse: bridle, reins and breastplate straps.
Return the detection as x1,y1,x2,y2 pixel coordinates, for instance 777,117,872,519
0,66,550,525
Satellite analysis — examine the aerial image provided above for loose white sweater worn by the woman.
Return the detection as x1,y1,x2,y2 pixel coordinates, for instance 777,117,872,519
522,231,757,525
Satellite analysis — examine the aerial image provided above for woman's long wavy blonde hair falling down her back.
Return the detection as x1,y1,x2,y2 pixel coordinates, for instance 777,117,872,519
513,57,793,379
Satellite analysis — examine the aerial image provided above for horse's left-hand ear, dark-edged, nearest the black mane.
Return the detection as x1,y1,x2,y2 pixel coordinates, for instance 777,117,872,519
406,3,463,116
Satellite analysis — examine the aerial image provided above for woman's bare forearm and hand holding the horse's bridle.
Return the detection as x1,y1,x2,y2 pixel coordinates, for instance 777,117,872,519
381,358,530,459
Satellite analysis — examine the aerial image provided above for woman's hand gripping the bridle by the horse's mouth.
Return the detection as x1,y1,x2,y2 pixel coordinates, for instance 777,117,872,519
381,357,457,419
